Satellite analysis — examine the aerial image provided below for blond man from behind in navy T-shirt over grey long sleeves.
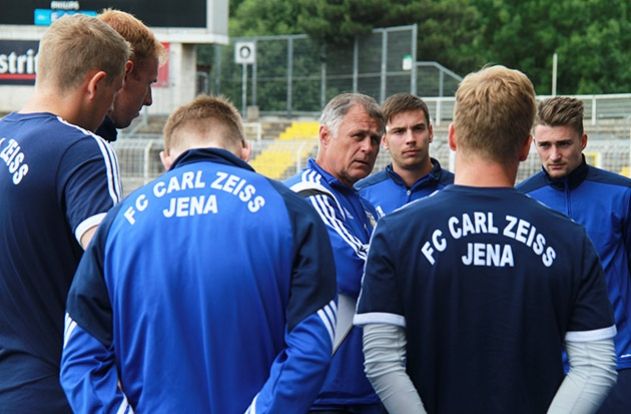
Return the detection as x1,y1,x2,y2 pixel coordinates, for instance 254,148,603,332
354,66,616,414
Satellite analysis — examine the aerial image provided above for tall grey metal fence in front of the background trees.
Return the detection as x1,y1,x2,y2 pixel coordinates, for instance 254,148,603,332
209,25,461,116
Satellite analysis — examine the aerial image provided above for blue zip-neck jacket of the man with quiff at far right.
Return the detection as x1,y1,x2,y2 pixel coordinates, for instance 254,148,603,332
517,159,631,369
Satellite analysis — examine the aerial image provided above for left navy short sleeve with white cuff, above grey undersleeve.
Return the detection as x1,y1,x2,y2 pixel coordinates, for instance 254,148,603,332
353,217,405,327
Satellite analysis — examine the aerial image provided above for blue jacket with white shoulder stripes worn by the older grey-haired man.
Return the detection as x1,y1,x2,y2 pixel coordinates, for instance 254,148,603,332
285,159,379,408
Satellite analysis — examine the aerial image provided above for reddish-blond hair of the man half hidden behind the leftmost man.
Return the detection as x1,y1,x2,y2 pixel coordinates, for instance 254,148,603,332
97,9,167,64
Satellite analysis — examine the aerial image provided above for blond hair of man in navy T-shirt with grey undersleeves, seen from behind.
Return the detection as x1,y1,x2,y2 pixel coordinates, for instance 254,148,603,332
454,65,536,161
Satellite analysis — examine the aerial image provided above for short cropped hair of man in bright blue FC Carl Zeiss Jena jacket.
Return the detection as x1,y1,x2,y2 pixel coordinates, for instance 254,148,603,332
163,95,245,154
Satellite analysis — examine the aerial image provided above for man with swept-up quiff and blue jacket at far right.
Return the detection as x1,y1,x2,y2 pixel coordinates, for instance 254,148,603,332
517,96,631,414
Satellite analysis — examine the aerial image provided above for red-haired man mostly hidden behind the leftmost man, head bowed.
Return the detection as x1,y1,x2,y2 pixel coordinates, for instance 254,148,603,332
96,9,167,142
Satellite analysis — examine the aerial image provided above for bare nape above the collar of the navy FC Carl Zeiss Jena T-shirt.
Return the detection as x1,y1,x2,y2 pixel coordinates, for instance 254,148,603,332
454,151,519,187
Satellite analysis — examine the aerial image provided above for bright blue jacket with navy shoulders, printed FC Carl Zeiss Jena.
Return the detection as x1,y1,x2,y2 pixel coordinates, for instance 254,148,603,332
61,149,336,413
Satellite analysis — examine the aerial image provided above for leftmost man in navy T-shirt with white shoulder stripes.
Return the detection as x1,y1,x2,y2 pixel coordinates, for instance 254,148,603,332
0,15,131,413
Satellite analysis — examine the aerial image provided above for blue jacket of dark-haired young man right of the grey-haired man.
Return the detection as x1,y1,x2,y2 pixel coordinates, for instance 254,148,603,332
355,158,454,216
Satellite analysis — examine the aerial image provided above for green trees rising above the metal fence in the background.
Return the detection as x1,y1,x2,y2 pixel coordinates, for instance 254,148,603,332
204,0,631,98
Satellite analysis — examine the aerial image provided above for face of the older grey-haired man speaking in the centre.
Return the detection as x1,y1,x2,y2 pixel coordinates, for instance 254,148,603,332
318,105,381,187
